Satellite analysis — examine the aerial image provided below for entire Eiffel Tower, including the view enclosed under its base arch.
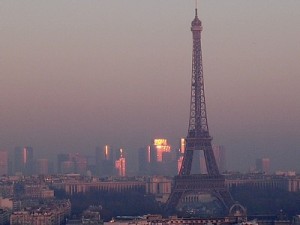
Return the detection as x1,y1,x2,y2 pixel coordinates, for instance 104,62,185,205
166,7,234,217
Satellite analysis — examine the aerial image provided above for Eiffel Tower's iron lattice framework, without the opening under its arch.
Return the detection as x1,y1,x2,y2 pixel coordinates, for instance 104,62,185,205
166,9,234,215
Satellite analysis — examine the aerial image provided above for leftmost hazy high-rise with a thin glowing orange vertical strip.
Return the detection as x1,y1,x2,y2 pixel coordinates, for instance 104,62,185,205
14,147,34,175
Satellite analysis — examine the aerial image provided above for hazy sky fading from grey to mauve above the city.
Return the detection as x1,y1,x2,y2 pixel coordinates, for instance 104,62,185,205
0,0,300,171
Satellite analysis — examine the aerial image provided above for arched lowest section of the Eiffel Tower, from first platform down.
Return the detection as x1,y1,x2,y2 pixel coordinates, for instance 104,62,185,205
166,174,234,217
